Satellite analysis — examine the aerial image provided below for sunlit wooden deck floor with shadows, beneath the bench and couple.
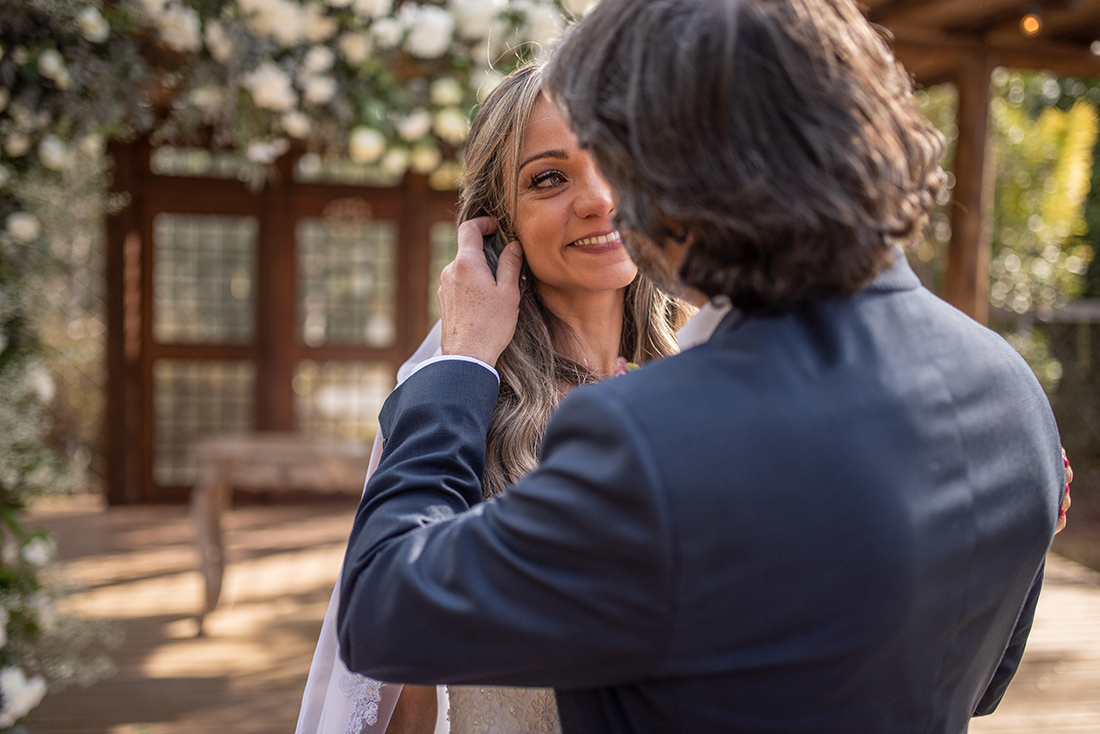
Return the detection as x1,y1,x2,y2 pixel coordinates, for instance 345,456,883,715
21,500,1100,734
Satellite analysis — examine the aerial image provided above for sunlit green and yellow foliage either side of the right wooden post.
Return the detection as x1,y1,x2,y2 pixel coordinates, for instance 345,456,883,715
912,69,1100,392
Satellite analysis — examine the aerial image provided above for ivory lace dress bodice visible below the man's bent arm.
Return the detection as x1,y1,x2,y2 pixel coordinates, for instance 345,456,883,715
448,686,561,734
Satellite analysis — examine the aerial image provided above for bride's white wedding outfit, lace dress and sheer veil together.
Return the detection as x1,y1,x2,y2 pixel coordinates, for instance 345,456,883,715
295,322,561,734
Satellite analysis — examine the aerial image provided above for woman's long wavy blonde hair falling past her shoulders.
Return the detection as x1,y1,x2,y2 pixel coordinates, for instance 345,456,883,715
458,64,691,497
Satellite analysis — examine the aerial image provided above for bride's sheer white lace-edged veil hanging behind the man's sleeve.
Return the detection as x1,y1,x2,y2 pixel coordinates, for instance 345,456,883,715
295,321,450,734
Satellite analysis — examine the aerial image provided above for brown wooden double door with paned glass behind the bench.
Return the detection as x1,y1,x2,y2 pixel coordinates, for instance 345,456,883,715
107,141,455,504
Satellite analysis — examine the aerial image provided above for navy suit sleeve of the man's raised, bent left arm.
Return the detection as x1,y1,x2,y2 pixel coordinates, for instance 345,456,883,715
339,362,672,688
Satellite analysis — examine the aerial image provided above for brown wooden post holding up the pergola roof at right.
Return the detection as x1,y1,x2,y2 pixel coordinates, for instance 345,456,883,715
944,50,993,324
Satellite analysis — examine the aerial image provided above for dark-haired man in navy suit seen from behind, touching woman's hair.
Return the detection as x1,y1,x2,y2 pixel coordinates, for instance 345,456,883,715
340,0,1064,734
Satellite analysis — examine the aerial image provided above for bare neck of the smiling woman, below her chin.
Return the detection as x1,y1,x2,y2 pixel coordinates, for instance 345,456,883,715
540,288,626,377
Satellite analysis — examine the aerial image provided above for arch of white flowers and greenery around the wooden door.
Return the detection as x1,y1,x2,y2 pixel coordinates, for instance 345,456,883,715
0,0,595,731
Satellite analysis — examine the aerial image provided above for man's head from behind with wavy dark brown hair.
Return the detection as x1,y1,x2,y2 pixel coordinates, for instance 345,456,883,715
546,0,943,311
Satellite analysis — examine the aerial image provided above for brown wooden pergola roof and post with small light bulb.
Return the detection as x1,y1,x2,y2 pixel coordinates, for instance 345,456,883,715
864,0,1100,322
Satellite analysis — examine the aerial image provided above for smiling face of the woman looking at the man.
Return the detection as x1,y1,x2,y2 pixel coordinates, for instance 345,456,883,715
515,97,638,300
